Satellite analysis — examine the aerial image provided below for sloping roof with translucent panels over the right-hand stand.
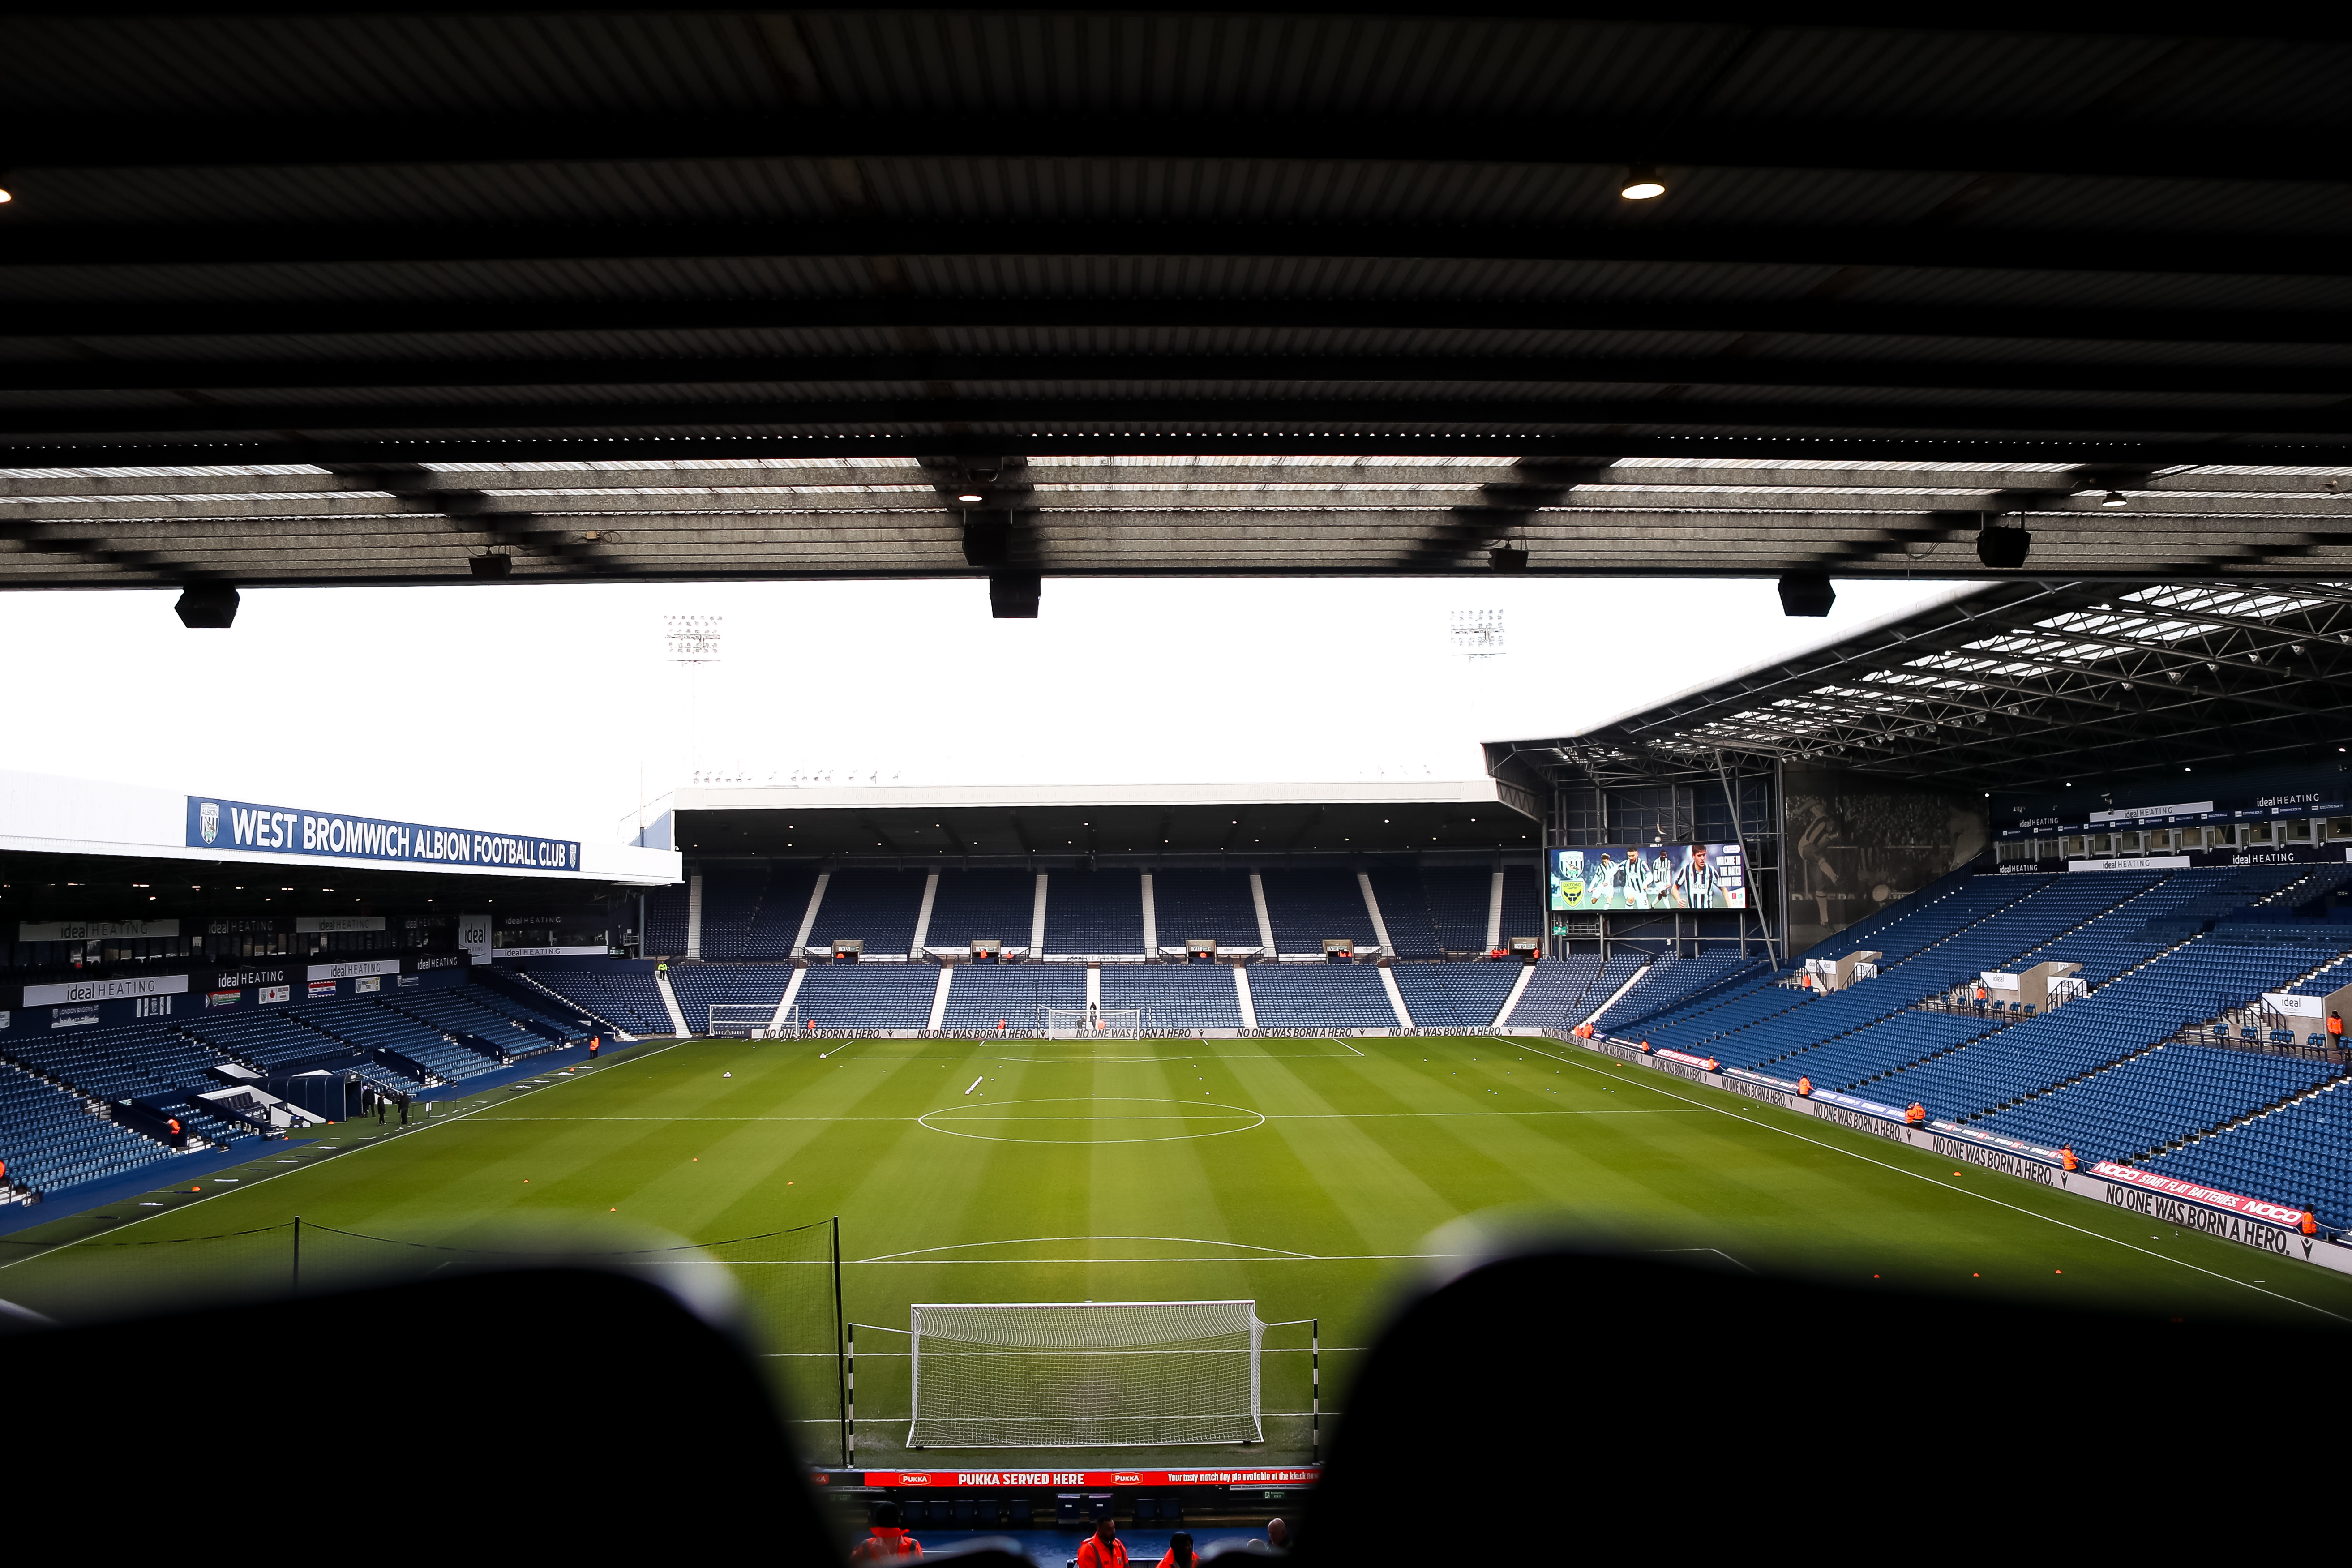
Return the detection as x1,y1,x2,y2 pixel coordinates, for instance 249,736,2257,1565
1487,581,2352,790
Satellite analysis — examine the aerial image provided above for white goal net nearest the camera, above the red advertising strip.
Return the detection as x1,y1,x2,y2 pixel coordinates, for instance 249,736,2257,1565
905,1302,1265,1448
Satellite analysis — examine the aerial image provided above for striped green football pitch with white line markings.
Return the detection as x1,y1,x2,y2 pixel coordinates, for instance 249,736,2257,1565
0,1037,2352,1467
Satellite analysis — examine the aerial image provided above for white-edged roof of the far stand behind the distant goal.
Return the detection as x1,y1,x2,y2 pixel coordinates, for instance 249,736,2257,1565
673,778,1543,863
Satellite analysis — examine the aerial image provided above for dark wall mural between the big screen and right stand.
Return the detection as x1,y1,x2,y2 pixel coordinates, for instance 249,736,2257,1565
1781,769,1992,952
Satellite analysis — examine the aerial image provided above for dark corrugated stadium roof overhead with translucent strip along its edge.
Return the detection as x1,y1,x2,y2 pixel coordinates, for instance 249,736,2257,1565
0,10,2352,588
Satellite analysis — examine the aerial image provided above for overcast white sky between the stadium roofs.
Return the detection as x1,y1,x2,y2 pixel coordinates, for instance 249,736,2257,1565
0,578,1954,842
